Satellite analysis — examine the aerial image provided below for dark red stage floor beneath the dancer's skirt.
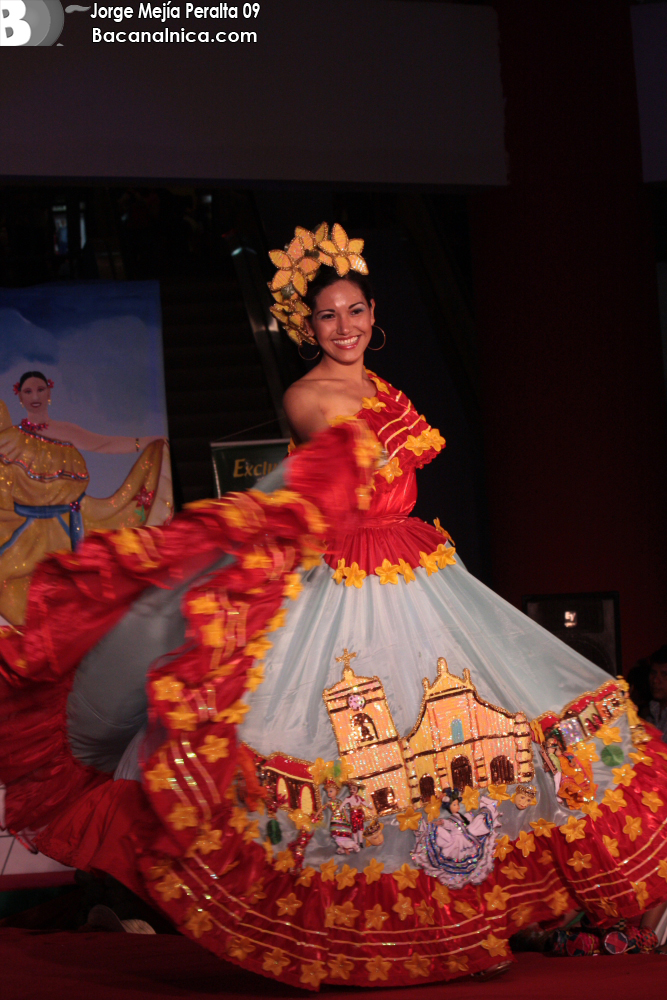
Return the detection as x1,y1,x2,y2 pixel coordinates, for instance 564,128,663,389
0,928,667,1000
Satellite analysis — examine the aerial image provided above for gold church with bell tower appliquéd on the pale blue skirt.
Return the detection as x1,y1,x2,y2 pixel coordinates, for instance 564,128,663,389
322,649,535,816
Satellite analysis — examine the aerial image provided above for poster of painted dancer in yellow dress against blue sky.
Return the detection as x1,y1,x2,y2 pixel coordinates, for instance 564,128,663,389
0,281,173,625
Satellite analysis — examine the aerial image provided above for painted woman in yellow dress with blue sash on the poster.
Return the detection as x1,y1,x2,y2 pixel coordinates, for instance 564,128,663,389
0,371,172,625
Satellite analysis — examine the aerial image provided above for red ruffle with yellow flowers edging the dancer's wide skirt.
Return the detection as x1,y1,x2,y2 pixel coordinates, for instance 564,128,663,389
0,422,667,989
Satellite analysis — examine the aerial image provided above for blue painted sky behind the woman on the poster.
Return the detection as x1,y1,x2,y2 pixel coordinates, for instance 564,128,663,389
0,281,168,497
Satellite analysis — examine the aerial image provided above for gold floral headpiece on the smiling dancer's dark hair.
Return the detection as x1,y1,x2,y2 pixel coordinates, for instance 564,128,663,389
269,222,368,345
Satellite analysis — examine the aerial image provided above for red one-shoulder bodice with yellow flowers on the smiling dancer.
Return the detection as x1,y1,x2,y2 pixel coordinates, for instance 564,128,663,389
325,372,449,582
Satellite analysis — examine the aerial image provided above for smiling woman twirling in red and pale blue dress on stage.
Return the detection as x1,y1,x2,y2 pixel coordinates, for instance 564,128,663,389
0,226,667,989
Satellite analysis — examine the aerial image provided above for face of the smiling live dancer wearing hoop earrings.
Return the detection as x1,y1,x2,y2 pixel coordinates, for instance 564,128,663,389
308,279,375,365
